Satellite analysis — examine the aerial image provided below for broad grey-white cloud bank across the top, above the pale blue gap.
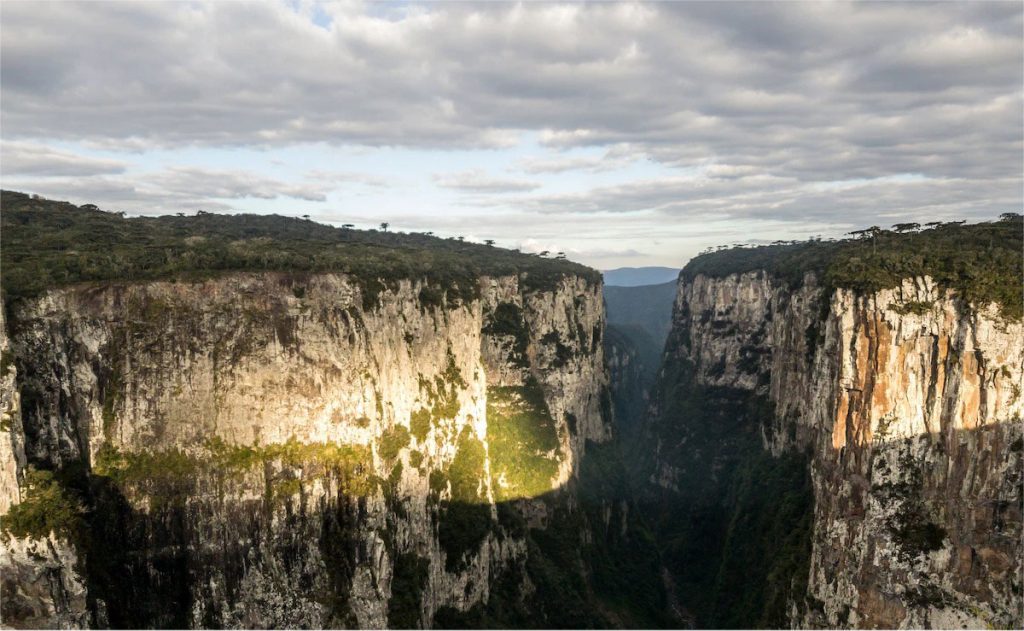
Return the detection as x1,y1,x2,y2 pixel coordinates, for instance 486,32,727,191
2,3,1022,180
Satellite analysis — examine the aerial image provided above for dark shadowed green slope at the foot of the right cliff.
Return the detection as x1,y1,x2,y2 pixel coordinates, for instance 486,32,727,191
635,353,814,629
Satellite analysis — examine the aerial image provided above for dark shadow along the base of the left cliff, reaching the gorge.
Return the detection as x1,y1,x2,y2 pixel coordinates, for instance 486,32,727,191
41,443,678,628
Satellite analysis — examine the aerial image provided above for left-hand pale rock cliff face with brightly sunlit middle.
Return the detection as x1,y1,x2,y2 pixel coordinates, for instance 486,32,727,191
0,274,617,628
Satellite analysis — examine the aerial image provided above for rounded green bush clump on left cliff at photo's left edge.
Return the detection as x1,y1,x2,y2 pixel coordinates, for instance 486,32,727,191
0,466,84,539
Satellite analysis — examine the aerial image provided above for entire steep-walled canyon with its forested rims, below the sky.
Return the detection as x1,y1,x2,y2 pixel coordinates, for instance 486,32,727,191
0,192,1024,628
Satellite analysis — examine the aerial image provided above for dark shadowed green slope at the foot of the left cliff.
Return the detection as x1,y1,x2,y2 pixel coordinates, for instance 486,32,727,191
432,443,678,629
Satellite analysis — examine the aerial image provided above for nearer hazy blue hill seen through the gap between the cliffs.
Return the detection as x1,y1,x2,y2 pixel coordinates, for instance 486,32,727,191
604,281,676,360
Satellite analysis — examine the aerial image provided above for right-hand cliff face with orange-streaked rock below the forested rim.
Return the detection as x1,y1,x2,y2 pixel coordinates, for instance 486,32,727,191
643,272,1024,628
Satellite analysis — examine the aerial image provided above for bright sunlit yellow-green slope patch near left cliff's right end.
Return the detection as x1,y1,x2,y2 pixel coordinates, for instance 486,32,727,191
487,377,562,501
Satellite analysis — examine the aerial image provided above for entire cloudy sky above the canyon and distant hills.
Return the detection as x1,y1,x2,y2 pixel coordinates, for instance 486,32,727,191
0,1,1024,268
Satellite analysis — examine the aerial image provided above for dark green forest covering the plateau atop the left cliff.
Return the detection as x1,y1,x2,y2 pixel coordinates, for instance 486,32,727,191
0,191,600,302
